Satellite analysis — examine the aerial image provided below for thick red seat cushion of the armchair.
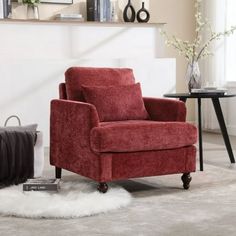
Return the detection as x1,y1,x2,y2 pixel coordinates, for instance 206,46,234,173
90,120,197,152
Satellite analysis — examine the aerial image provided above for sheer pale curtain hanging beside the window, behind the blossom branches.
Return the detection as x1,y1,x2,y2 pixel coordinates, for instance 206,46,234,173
200,0,229,130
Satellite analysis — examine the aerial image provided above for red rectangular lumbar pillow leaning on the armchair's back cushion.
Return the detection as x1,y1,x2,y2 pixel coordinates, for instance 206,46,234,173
82,83,149,121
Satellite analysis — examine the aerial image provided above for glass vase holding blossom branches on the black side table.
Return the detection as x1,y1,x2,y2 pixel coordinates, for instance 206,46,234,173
186,61,201,93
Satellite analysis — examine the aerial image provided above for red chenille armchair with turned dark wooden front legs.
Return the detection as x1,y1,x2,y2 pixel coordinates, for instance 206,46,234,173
50,67,197,193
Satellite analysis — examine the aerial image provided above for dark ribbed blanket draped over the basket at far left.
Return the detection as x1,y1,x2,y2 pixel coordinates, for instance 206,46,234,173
0,131,36,188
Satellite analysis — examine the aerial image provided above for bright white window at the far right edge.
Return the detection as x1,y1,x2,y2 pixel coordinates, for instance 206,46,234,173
225,0,236,82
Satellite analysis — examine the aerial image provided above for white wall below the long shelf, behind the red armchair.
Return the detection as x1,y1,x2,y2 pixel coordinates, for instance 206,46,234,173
0,22,176,146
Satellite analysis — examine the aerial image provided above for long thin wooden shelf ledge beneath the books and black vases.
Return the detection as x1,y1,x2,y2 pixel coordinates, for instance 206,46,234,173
0,19,166,27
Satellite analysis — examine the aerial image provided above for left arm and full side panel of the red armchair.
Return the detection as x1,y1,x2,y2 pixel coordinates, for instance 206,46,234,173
50,100,111,182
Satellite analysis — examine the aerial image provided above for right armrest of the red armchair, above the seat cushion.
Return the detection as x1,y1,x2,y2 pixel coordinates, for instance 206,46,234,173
143,97,186,122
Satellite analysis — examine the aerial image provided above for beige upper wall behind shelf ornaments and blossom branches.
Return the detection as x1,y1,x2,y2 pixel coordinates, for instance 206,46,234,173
10,0,195,121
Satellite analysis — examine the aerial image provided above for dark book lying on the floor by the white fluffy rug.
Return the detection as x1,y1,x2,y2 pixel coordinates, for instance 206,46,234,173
23,178,60,191
